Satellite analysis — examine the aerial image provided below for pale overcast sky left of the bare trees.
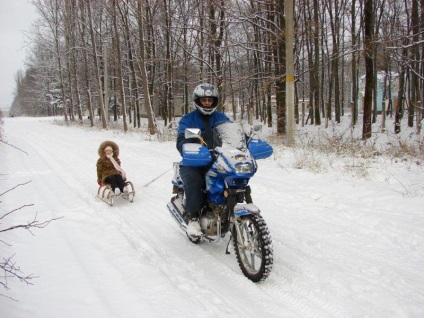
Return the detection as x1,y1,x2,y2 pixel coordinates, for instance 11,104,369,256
0,0,37,109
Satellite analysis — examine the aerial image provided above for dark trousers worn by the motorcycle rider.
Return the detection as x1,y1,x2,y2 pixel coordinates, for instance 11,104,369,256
180,166,207,219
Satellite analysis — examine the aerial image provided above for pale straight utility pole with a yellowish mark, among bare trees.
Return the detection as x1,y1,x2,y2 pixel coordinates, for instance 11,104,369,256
284,0,295,146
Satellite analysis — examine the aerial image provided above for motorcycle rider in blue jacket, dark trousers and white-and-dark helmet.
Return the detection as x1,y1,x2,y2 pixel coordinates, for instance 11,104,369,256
177,83,230,236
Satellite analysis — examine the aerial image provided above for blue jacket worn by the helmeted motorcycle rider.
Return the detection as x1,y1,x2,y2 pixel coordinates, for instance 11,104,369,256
177,110,230,154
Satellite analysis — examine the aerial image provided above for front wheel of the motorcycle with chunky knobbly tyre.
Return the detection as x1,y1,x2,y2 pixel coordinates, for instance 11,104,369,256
233,214,273,283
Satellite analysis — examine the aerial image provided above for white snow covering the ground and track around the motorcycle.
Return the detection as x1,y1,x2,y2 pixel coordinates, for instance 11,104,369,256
0,118,424,318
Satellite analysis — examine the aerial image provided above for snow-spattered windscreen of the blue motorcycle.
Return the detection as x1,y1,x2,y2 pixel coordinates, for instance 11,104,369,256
213,122,246,151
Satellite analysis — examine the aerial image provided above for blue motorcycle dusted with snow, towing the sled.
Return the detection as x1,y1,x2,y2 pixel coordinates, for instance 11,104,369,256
167,122,273,282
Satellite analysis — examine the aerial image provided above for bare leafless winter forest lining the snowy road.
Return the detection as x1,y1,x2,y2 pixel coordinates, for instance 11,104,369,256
10,0,424,139
